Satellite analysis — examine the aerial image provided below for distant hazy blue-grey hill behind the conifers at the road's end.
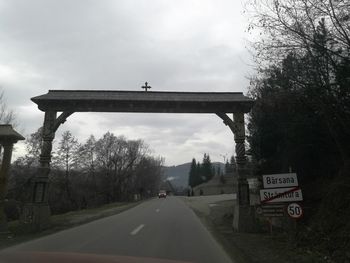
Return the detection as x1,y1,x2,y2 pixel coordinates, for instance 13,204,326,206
163,162,225,188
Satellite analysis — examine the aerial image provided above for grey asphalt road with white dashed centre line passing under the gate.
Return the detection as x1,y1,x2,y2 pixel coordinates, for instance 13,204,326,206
3,196,232,263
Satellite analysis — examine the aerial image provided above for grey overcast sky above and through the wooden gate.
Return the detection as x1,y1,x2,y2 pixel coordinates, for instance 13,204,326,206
0,0,252,165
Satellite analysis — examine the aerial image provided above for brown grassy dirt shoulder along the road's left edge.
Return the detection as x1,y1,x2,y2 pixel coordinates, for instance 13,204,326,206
0,201,142,249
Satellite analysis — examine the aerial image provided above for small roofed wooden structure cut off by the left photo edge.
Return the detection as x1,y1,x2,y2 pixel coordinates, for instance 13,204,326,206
0,124,25,233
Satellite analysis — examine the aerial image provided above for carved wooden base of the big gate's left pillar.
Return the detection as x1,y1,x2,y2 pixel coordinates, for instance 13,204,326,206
20,203,51,232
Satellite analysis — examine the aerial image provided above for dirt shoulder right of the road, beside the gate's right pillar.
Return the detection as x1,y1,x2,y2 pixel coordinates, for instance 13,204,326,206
183,197,332,263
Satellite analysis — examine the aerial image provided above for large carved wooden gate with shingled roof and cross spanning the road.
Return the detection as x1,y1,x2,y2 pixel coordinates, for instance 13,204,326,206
23,89,254,231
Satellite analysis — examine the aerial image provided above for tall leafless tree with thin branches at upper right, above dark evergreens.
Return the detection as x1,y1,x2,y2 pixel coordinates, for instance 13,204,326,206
247,0,350,161
